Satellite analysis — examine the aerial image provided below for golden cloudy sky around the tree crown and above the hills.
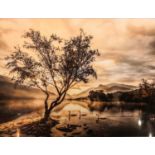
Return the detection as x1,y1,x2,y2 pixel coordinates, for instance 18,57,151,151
0,19,155,91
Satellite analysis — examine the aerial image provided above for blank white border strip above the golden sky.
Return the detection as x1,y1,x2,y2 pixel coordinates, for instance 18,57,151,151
0,0,155,18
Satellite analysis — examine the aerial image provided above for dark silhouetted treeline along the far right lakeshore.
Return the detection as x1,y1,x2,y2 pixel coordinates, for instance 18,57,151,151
88,79,155,104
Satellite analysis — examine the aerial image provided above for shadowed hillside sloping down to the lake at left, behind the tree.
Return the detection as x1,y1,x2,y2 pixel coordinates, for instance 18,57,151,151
0,75,43,99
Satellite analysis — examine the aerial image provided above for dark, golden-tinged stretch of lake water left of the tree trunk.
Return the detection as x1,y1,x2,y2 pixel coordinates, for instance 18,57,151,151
0,99,43,124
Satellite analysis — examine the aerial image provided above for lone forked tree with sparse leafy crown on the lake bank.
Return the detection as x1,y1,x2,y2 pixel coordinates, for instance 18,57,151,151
6,29,99,121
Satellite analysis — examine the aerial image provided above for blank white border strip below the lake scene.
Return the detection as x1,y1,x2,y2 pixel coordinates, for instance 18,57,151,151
0,137,155,155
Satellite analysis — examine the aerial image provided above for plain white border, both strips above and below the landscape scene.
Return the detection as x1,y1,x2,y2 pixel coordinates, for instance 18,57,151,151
0,0,155,155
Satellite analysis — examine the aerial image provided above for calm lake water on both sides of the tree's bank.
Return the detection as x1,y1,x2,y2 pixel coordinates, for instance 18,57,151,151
0,100,155,137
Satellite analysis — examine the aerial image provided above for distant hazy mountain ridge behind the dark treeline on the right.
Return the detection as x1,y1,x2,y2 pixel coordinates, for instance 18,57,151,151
71,83,136,99
